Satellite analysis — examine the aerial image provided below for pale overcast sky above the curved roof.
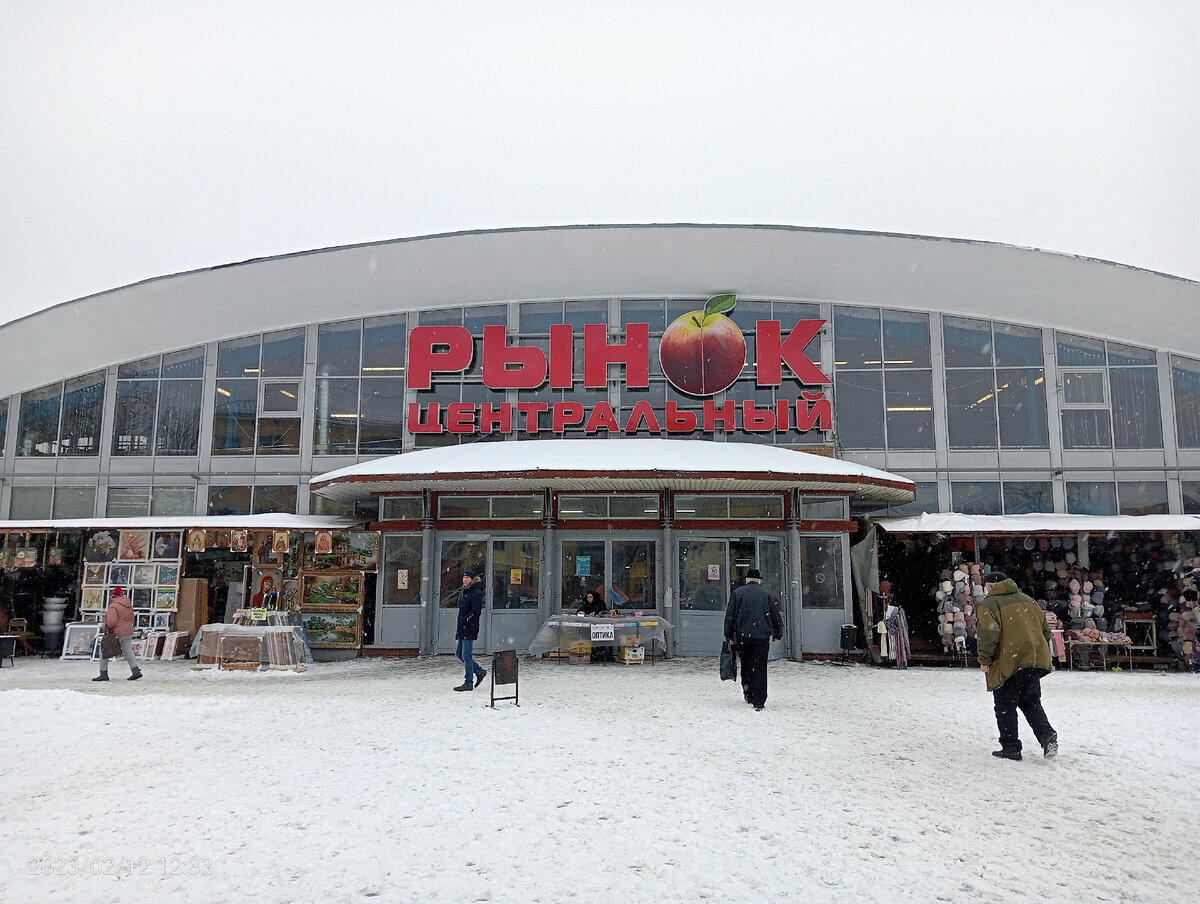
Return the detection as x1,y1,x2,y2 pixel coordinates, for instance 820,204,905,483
0,0,1200,321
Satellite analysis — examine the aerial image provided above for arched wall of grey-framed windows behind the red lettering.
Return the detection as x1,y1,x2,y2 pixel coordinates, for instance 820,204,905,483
0,297,1200,520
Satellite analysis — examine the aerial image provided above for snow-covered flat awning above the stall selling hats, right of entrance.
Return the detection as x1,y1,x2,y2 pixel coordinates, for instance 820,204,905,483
875,511,1200,534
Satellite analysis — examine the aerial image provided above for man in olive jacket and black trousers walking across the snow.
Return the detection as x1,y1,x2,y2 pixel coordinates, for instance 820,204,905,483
976,571,1058,760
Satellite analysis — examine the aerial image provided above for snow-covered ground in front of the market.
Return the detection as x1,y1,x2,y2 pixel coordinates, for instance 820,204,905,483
0,657,1200,904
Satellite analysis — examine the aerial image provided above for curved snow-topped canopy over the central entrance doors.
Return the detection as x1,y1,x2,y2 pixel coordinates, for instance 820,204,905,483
310,439,916,503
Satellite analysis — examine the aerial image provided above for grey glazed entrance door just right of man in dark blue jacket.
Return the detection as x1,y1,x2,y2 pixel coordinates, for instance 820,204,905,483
489,539,541,652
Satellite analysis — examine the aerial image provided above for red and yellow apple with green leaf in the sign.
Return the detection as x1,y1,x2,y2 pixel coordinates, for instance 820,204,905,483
659,295,746,395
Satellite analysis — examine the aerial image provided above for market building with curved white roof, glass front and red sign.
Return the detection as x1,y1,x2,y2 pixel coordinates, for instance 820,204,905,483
0,224,1200,658
